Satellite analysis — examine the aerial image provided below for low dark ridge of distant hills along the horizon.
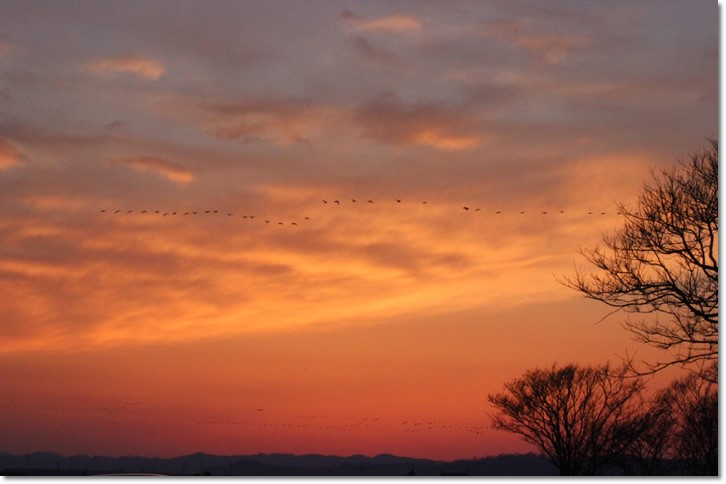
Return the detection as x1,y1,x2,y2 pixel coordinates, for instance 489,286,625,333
0,452,557,477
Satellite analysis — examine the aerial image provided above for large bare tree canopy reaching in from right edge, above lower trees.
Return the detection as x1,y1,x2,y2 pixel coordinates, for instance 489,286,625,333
564,140,718,382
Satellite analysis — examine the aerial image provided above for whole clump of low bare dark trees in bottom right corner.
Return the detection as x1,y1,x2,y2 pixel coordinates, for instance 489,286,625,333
489,364,718,476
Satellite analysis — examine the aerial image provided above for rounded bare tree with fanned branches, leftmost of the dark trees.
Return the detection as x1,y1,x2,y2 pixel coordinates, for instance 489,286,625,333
488,364,650,475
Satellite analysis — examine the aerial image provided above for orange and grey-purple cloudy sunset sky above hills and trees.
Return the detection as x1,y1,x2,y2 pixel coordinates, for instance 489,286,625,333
0,0,719,459
